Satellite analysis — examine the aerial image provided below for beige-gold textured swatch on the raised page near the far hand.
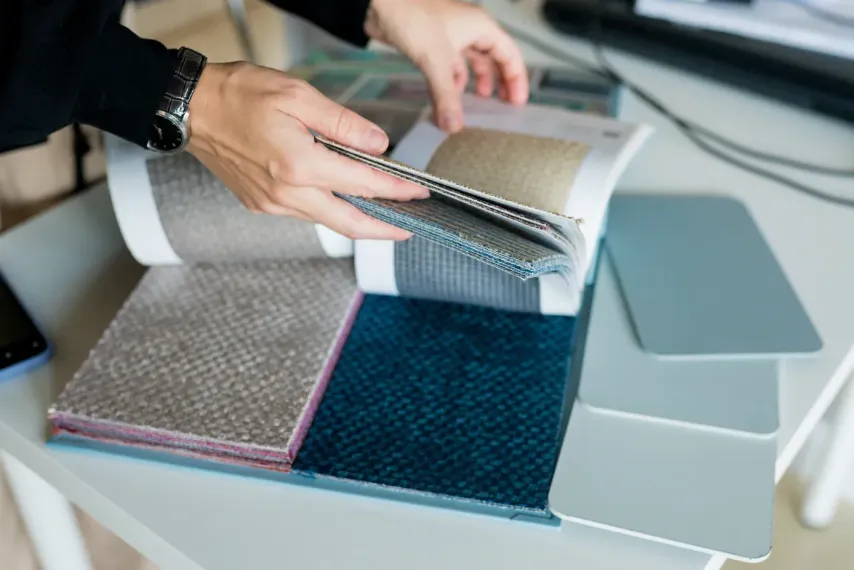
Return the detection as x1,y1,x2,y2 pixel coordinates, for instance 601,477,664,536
425,127,589,214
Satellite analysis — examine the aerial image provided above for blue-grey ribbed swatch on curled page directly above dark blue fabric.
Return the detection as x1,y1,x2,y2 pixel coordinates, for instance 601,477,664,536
394,236,540,313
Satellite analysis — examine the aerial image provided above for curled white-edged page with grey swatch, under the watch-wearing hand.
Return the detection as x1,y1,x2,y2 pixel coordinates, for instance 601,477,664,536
107,137,353,265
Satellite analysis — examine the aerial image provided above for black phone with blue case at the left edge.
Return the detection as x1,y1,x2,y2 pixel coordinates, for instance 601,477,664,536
0,275,51,381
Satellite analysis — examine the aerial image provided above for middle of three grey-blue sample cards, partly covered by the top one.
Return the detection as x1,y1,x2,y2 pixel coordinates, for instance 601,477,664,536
578,255,779,437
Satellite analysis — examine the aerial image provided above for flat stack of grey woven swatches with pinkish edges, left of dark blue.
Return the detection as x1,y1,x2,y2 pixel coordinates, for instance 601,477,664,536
51,259,359,461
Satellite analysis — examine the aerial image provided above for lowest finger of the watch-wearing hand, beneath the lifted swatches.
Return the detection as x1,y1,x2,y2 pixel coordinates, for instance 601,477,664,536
294,188,412,241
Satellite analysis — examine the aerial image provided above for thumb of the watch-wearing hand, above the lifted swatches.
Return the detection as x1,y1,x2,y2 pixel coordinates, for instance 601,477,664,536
288,80,388,154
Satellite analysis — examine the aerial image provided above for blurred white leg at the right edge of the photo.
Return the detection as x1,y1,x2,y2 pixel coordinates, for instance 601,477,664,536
801,380,854,528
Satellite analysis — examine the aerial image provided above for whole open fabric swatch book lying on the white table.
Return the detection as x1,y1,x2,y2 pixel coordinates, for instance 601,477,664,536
49,57,647,523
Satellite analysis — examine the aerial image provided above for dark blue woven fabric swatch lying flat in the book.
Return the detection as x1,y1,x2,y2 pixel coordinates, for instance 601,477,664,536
294,295,575,512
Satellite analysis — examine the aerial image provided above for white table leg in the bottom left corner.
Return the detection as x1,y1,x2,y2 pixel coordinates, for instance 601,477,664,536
0,451,92,570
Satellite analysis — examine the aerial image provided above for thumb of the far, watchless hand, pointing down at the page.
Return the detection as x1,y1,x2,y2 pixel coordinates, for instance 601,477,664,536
418,52,466,133
